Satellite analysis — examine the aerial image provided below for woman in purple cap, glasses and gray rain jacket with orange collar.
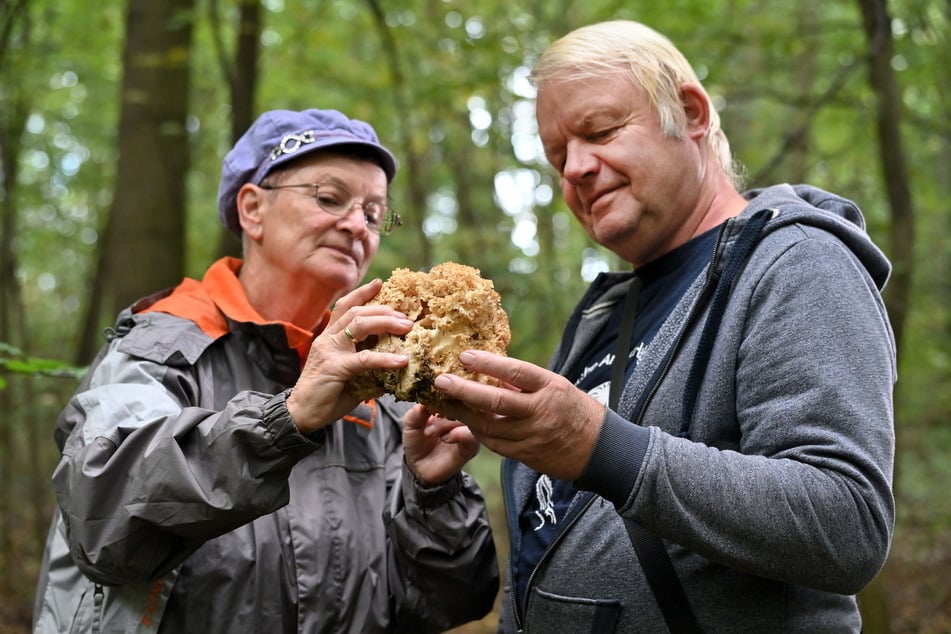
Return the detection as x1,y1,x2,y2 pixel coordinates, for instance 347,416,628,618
34,110,498,634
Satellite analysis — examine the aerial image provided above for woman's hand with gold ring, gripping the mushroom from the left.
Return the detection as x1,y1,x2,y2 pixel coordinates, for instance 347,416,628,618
287,279,413,434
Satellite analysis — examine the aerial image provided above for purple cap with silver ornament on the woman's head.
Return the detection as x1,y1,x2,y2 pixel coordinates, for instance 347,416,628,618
218,110,397,235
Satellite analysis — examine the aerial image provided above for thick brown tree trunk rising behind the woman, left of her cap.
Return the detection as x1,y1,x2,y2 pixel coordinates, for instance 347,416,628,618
83,0,194,360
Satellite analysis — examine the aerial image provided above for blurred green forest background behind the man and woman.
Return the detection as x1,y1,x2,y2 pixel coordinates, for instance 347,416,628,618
0,0,951,632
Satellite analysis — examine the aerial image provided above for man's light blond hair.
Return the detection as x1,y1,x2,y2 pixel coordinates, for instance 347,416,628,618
531,20,740,185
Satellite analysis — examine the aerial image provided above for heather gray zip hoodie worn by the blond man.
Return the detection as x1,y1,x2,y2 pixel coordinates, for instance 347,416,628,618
500,185,896,634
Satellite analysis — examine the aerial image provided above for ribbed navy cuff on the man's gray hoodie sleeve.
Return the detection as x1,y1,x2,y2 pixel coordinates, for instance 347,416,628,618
575,410,650,508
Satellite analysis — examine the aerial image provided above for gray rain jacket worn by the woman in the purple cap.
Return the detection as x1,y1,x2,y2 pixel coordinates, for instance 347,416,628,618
34,258,498,634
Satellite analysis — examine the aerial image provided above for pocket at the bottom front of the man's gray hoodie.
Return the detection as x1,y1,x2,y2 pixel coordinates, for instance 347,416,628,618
525,588,621,634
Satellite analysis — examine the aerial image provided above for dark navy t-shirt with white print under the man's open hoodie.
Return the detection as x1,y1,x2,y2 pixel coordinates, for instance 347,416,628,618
514,229,717,602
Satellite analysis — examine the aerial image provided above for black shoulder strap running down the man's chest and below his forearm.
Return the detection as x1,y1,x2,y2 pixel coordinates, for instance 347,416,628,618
608,277,700,634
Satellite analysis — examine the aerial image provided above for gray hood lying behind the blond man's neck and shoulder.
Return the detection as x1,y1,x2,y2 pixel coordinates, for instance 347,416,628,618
743,184,892,290
